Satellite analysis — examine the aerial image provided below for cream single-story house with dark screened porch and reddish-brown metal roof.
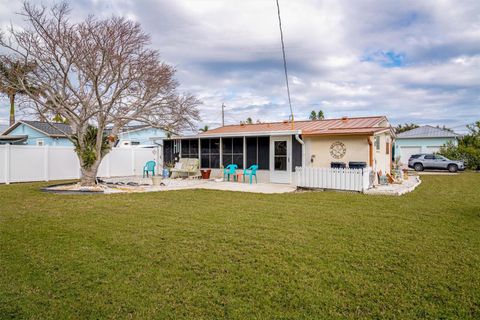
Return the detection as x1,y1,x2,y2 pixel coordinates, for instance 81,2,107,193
163,116,395,183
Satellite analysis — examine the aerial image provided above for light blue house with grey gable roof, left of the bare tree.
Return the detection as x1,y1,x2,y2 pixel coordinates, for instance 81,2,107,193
0,120,73,146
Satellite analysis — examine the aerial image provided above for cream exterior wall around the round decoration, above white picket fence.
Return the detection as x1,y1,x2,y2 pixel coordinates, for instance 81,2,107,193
304,136,369,168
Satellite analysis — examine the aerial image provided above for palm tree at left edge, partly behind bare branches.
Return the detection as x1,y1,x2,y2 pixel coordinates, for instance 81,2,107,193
0,56,33,126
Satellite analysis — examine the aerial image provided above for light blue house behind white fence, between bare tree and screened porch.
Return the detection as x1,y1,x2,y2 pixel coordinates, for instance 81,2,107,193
117,125,166,148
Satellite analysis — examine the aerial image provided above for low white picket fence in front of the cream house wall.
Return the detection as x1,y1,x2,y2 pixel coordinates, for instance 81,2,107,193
295,167,372,192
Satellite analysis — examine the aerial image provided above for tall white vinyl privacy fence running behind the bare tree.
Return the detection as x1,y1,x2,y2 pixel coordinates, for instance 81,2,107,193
0,145,161,184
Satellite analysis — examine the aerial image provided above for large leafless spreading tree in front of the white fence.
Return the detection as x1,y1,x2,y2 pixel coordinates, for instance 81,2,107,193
0,2,200,186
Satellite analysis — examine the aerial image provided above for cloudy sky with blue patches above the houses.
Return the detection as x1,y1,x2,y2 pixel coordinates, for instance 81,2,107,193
0,0,480,131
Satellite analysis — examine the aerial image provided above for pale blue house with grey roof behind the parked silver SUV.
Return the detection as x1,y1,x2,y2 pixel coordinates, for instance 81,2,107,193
394,126,460,165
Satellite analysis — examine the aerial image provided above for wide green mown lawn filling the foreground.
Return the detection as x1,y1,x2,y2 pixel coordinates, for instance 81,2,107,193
0,173,480,319
